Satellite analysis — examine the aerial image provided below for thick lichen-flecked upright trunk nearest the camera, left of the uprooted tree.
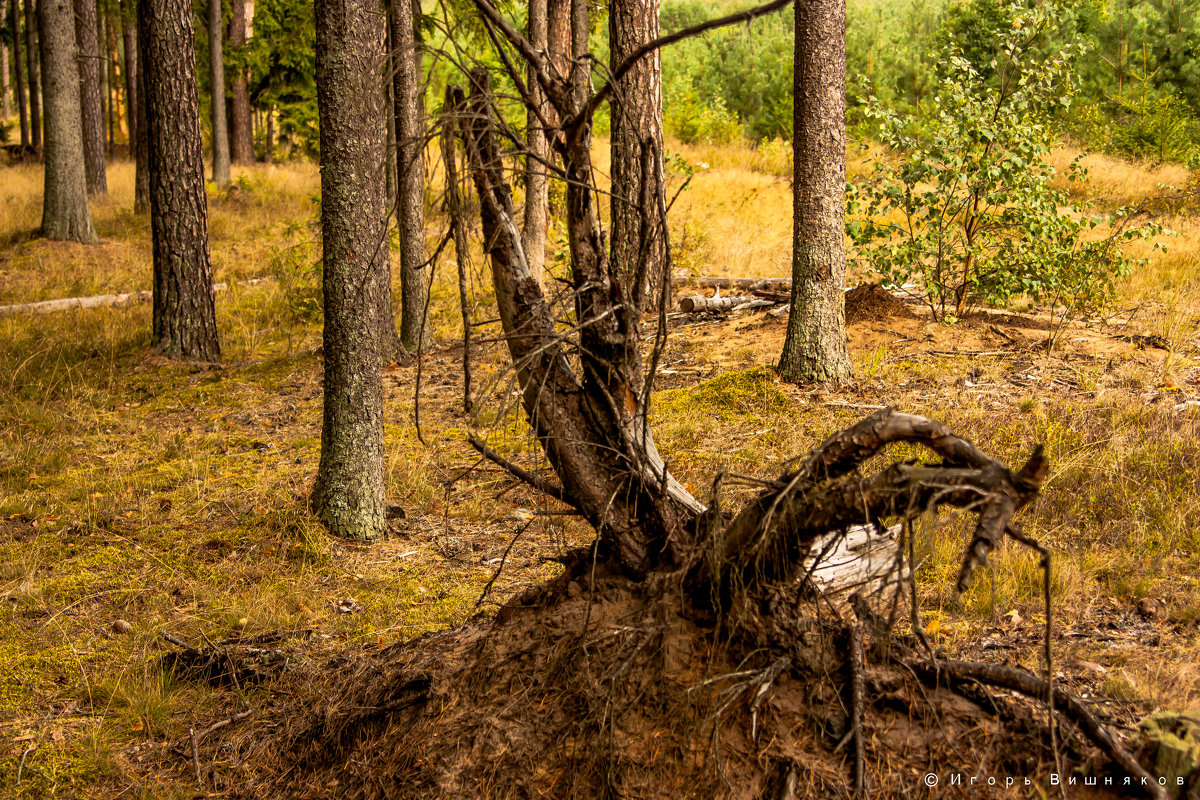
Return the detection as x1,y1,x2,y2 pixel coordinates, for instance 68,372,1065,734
312,0,389,540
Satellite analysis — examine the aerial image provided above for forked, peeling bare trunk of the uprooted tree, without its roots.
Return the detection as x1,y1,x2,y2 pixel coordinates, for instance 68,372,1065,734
466,65,703,576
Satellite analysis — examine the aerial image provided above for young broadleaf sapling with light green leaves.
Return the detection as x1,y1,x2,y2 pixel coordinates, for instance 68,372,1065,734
847,6,1160,331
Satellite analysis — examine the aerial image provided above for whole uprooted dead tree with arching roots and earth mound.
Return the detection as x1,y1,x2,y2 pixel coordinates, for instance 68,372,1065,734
204,0,1158,798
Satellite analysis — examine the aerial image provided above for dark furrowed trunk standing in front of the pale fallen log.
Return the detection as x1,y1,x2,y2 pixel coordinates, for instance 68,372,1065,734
142,0,221,361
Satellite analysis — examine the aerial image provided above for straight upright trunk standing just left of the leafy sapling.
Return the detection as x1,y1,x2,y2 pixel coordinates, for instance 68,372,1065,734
779,0,851,383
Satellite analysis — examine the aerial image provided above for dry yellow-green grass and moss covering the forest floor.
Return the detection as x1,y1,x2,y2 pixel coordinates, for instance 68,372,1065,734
0,149,1200,798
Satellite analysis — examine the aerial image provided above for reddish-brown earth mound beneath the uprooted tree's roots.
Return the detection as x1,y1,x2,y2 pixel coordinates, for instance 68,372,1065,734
202,568,1104,800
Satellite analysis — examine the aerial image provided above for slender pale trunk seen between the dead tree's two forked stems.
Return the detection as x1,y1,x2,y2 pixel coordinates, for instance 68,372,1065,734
521,0,550,285
